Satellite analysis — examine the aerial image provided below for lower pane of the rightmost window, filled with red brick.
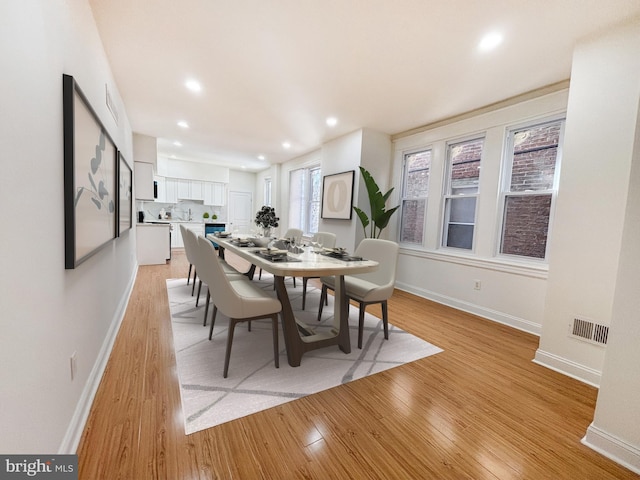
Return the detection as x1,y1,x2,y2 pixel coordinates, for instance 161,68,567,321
500,195,551,258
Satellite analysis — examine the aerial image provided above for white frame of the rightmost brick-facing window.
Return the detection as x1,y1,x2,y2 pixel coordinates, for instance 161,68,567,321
495,113,566,264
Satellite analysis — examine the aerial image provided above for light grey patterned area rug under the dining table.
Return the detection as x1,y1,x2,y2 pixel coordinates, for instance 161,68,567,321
167,273,442,434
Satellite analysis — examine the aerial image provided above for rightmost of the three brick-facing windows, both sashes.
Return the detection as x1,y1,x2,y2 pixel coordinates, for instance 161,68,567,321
500,120,564,259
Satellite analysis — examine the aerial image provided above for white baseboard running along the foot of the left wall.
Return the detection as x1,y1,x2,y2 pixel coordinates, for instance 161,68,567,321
58,263,138,455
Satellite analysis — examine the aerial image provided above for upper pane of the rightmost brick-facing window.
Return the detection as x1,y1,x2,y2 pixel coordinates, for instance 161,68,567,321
510,122,562,192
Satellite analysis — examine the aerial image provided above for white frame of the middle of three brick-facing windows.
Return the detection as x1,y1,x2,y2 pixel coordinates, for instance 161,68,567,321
440,133,486,253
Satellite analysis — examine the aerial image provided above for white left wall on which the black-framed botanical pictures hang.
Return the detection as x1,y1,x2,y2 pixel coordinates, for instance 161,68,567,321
0,0,136,454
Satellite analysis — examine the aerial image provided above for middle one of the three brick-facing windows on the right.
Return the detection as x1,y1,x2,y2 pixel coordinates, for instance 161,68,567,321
442,138,484,250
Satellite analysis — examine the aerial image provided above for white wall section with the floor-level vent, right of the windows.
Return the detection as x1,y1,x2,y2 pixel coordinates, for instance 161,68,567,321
536,20,640,385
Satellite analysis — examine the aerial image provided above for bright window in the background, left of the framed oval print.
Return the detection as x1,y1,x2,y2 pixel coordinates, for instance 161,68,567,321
289,167,322,234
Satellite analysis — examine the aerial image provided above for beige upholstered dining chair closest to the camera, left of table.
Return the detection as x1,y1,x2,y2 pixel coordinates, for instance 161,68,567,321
198,237,282,378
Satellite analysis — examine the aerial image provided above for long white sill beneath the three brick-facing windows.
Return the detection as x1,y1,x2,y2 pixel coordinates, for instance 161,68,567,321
400,245,549,279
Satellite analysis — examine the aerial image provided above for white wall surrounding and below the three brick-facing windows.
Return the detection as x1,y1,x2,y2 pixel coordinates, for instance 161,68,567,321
389,90,568,334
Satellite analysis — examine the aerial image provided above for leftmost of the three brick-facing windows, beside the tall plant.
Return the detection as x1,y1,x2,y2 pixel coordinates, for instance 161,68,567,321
400,150,431,244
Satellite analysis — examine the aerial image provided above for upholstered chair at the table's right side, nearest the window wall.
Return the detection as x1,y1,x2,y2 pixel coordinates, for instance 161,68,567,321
318,238,399,348
